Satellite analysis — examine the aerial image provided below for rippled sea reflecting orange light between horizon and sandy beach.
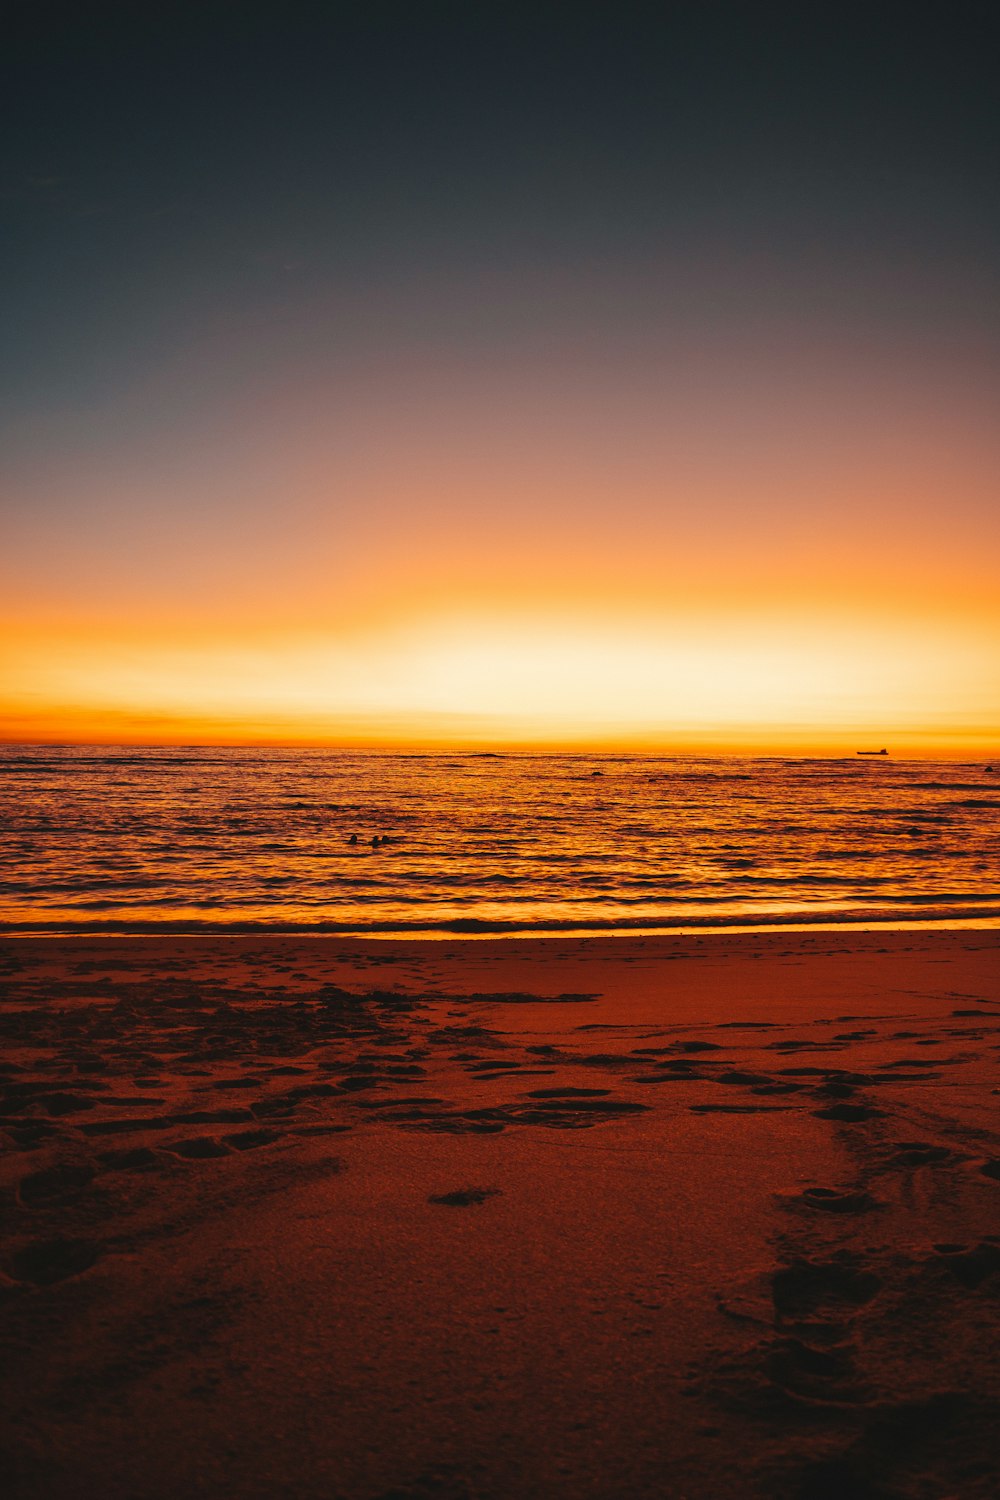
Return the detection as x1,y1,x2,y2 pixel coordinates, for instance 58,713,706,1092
0,746,1000,935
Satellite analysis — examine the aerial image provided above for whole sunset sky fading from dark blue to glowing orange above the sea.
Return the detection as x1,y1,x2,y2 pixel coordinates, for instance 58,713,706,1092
0,0,1000,758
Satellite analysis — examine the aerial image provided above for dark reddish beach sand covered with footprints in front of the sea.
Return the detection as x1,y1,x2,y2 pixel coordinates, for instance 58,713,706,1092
0,930,1000,1500
